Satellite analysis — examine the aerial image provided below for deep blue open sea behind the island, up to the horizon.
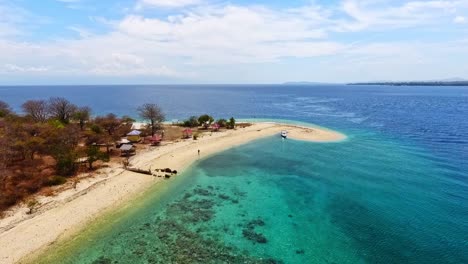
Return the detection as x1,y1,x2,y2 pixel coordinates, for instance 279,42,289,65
0,85,468,179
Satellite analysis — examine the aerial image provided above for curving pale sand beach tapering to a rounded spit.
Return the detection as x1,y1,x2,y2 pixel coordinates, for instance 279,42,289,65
0,122,346,263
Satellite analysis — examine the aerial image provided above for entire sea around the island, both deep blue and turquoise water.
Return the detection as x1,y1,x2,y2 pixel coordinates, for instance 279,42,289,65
0,85,468,263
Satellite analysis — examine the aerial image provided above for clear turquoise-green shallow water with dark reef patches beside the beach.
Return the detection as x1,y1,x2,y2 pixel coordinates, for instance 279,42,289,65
37,133,468,263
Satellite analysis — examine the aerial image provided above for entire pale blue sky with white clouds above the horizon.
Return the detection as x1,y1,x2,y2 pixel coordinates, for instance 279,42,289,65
0,0,468,85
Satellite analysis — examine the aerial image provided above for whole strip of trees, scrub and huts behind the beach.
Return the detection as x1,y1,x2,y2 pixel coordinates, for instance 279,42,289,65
0,97,236,217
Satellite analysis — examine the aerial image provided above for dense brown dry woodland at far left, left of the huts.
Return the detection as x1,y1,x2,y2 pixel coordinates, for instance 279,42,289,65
0,97,143,213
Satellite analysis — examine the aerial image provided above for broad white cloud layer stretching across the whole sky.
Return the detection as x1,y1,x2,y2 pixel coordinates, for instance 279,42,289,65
0,0,468,83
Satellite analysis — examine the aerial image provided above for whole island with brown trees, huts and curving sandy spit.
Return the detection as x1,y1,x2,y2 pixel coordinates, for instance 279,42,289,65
0,98,346,263
